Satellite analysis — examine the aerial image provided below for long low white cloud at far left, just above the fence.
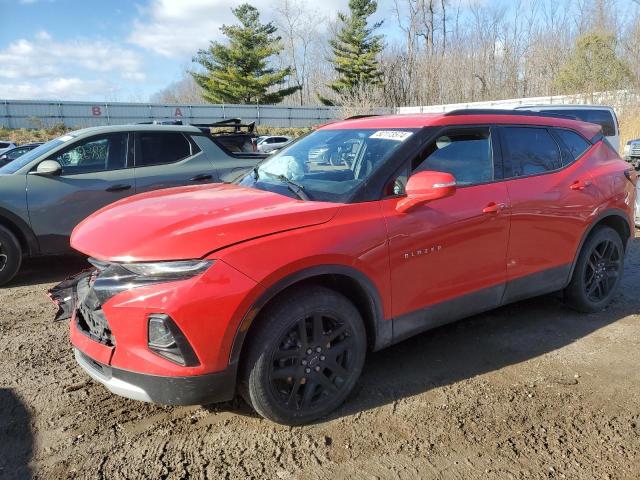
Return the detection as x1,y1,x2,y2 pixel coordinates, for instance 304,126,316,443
0,31,144,80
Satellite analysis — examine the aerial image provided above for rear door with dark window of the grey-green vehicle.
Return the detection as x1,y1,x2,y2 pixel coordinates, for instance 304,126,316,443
135,132,218,193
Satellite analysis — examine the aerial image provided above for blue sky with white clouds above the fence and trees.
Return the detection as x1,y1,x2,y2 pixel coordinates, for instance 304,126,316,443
0,0,392,101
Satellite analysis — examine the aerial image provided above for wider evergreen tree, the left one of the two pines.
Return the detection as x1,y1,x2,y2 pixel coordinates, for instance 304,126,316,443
191,3,299,104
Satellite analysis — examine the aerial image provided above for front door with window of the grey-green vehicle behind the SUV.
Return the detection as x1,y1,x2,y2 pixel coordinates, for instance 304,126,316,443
27,133,135,253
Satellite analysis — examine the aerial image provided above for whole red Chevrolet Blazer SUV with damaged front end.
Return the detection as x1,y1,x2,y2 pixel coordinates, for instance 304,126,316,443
53,110,636,424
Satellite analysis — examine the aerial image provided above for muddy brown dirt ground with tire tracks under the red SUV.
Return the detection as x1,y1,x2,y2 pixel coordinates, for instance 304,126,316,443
0,239,640,480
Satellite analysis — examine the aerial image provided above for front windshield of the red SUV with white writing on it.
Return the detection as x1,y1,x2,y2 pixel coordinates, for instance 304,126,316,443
239,129,415,202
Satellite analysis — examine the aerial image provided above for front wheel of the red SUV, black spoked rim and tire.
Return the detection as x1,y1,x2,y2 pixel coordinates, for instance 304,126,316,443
240,286,367,425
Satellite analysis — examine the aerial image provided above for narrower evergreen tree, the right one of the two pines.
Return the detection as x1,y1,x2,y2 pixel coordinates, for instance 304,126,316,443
320,0,382,105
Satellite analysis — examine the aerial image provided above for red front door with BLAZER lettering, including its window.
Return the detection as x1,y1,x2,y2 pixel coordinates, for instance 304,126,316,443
383,127,510,337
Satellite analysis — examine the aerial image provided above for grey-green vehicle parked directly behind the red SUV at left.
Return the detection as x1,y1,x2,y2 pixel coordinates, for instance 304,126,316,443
0,125,266,285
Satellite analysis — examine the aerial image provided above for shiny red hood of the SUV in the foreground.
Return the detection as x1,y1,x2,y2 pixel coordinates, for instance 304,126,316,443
71,184,340,262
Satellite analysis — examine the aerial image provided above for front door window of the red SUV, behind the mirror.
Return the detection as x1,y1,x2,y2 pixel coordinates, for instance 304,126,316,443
413,128,494,185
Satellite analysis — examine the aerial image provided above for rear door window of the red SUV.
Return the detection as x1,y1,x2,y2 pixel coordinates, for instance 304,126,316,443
503,127,562,177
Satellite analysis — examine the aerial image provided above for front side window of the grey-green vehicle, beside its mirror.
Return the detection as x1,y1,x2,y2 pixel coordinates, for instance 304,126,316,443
49,133,127,175
